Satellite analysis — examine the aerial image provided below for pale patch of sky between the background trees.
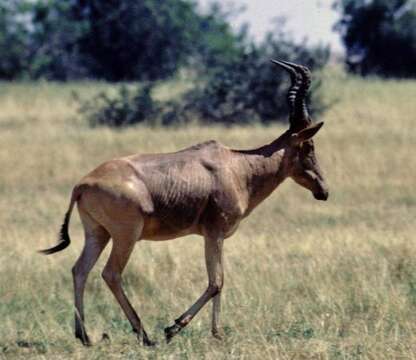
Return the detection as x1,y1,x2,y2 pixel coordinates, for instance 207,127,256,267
198,0,342,52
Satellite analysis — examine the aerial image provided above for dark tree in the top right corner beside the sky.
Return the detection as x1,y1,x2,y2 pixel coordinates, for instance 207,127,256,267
334,0,416,77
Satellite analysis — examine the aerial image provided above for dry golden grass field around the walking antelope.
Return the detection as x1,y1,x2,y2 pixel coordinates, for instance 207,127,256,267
0,71,416,359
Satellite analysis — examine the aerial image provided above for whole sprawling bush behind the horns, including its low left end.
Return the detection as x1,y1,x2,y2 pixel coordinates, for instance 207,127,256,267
79,27,329,126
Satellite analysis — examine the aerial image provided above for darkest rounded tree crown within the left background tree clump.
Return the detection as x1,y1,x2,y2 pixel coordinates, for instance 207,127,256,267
67,0,198,81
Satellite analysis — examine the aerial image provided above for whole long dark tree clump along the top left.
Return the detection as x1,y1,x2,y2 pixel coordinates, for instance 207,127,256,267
6,0,238,81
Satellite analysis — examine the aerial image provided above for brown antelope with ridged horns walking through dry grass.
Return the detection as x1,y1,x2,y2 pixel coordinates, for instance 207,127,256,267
41,60,328,346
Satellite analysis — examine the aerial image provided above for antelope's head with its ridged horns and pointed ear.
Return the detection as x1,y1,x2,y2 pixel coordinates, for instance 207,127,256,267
272,60,328,200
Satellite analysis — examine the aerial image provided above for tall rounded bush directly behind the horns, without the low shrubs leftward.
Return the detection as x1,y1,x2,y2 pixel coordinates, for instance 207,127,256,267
185,34,329,124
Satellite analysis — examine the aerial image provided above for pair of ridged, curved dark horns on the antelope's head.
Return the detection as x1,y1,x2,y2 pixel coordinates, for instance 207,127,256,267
272,60,311,130
